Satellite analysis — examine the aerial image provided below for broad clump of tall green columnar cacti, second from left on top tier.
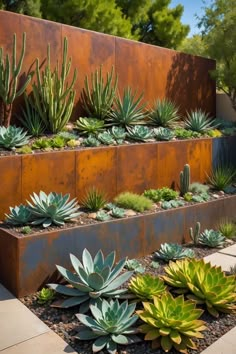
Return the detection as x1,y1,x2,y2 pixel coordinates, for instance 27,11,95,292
33,38,77,133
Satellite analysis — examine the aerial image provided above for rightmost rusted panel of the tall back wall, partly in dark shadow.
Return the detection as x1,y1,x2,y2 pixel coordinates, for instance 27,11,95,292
116,38,215,116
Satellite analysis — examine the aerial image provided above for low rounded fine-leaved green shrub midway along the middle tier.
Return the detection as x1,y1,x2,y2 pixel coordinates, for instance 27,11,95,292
114,192,153,212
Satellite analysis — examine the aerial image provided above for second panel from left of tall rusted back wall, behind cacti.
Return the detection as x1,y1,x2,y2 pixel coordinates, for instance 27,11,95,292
62,25,115,120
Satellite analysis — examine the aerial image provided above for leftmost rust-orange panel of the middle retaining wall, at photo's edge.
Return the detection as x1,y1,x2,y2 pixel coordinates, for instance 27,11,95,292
0,156,21,220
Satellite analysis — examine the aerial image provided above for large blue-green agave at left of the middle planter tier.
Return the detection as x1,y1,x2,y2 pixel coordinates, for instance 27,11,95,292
27,191,80,227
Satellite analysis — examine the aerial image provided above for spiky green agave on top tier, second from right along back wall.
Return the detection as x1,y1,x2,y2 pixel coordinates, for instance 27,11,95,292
149,99,180,127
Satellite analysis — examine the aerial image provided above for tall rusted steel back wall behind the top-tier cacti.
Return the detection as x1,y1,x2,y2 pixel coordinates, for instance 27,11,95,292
0,11,216,118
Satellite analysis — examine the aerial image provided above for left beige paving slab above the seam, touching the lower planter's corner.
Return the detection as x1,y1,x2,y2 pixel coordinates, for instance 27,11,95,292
0,286,50,351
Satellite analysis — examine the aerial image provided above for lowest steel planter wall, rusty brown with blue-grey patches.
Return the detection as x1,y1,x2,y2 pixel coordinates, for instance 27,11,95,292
0,196,236,297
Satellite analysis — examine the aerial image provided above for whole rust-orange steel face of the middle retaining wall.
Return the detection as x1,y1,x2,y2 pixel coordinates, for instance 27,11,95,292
0,136,236,220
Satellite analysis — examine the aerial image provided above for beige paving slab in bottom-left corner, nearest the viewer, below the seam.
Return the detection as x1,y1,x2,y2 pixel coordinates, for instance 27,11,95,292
1,331,77,354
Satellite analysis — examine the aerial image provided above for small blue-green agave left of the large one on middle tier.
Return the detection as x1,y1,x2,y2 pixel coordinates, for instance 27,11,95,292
5,204,32,225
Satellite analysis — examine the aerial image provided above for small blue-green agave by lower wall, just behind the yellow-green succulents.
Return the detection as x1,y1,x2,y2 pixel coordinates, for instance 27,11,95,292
155,243,195,262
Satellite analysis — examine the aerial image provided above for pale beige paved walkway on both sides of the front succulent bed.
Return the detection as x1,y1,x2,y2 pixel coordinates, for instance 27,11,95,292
0,245,236,354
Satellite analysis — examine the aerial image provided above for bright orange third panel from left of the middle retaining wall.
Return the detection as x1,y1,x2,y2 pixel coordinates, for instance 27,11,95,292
76,147,117,199
